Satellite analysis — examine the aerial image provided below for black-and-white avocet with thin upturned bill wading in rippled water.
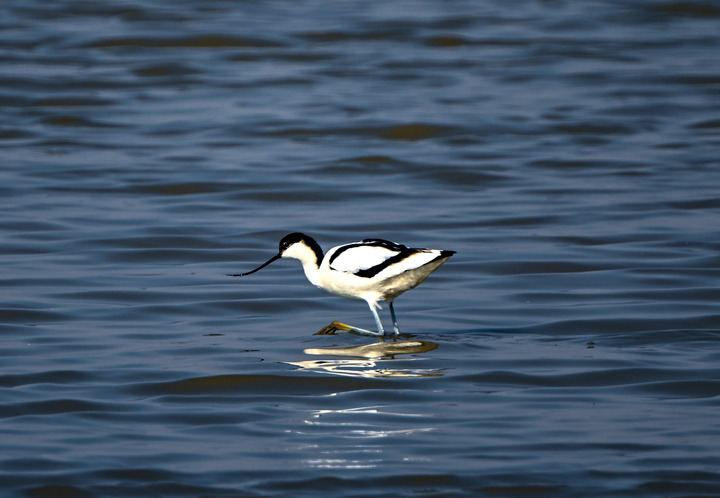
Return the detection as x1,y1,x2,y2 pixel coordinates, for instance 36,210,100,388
228,232,455,337
